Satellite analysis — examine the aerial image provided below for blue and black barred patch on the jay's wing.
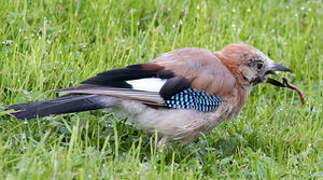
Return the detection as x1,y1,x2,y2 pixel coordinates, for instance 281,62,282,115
165,88,223,112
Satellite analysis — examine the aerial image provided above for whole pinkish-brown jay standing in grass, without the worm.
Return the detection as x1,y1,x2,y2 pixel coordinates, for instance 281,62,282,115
6,43,291,147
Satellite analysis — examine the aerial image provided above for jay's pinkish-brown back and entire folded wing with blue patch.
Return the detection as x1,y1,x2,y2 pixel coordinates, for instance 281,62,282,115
56,48,235,111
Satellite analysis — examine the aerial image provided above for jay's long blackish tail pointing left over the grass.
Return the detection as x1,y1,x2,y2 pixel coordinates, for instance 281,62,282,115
6,94,119,120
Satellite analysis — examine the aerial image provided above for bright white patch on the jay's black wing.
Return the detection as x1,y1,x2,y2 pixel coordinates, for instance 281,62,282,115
126,78,167,92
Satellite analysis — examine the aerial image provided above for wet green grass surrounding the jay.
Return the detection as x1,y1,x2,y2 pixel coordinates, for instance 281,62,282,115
0,0,323,179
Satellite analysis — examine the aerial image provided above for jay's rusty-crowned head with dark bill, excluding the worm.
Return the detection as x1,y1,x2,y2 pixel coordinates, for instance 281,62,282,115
215,44,291,89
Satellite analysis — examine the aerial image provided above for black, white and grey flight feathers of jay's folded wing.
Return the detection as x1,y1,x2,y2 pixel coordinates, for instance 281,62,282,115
54,63,173,107
